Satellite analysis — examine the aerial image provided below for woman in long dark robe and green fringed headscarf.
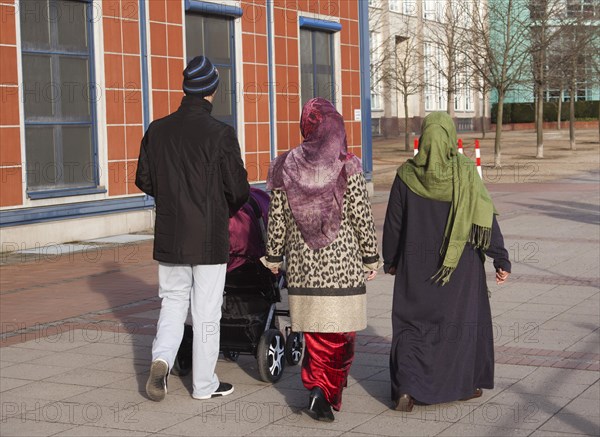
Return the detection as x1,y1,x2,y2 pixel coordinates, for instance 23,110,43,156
383,112,511,411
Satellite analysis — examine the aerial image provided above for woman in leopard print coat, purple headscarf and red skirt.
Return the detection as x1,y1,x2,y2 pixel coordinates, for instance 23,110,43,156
264,98,381,421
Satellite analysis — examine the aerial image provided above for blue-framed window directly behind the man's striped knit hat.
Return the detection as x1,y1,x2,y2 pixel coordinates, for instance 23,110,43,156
185,11,236,128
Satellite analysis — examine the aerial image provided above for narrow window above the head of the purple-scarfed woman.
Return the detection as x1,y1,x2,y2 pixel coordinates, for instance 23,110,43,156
300,29,335,104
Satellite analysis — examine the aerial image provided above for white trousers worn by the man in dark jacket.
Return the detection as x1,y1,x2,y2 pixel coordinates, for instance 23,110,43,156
152,263,227,396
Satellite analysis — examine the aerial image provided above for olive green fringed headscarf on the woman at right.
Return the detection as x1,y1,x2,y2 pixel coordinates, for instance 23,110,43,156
398,112,496,285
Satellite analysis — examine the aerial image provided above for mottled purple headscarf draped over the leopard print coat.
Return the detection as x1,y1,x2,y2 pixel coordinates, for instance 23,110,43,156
267,97,362,250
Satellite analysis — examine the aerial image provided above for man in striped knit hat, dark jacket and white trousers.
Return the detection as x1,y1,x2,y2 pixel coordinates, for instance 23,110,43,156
135,56,250,401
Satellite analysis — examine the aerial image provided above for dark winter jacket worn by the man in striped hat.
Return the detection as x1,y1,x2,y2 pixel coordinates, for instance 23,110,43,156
135,96,250,264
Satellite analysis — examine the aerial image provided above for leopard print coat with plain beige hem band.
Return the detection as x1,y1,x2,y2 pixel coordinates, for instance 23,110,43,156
266,173,379,332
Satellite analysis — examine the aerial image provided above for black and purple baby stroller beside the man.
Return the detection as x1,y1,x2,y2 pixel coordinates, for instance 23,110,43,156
171,188,304,382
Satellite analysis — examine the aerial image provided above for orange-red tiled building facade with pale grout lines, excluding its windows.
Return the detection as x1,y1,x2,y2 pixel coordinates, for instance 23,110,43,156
0,0,363,228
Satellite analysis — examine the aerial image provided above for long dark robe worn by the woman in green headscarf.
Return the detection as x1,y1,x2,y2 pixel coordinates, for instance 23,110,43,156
383,177,511,404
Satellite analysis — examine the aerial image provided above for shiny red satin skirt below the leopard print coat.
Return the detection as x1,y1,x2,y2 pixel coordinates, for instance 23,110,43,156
302,332,356,411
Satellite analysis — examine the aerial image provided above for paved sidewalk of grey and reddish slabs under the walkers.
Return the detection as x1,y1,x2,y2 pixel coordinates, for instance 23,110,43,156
0,173,600,437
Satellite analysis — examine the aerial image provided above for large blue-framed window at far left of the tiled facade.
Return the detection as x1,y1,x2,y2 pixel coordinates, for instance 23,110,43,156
19,0,98,194
